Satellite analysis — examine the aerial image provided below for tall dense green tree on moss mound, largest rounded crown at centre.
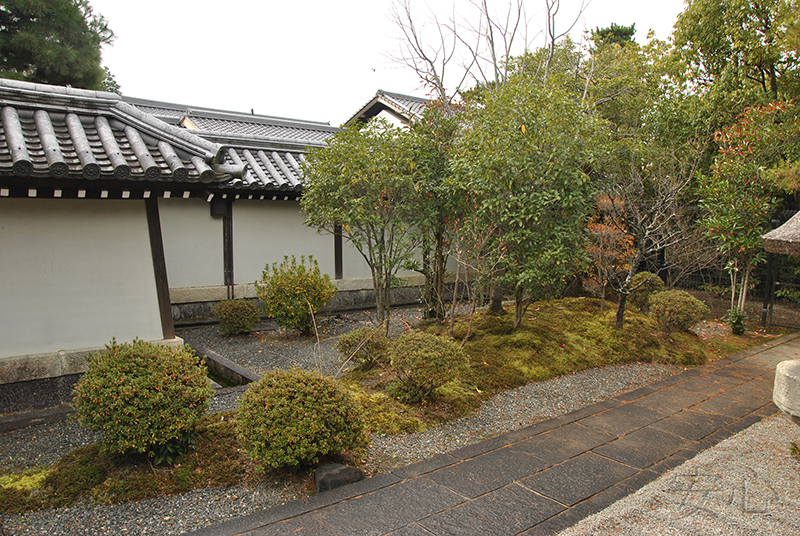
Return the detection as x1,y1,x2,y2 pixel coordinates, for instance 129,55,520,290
453,76,602,327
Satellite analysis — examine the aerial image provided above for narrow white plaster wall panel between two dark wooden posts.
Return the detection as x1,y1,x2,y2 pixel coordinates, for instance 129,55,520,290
158,198,223,288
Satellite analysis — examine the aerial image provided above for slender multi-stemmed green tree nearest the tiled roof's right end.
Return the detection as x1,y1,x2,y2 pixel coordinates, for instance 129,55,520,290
300,118,420,329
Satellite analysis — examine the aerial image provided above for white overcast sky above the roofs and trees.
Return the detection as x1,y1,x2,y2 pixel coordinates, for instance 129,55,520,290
90,0,683,126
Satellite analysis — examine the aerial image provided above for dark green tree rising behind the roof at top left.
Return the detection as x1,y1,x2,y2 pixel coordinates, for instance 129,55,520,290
0,0,119,90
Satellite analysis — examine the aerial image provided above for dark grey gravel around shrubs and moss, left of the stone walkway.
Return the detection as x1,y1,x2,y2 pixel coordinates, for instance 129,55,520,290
0,309,681,536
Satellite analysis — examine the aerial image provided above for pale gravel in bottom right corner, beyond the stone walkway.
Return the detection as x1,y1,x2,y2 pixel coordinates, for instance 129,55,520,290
561,414,800,536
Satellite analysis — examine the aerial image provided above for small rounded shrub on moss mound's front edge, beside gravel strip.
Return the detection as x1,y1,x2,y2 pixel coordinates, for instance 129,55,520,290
389,331,469,402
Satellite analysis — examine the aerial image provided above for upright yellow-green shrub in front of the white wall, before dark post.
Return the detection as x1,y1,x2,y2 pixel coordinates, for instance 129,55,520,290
256,255,336,333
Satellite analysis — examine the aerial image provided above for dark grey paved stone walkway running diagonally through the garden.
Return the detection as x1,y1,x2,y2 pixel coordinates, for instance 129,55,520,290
192,334,800,536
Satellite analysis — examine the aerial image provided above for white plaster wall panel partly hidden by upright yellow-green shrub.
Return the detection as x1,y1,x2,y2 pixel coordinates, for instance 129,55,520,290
233,200,340,284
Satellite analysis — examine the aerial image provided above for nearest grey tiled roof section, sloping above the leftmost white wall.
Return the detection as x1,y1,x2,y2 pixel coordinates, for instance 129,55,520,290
0,79,231,188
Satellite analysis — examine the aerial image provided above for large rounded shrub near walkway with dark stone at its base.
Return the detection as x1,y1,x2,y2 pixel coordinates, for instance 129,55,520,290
237,369,368,468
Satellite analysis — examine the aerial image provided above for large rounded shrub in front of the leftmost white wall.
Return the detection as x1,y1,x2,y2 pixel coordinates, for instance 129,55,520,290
73,340,214,453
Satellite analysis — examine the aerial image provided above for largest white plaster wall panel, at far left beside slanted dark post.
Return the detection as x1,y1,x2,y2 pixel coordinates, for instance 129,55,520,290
0,198,163,357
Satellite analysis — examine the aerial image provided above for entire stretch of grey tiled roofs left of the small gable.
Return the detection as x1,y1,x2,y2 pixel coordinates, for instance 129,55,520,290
0,79,338,197
